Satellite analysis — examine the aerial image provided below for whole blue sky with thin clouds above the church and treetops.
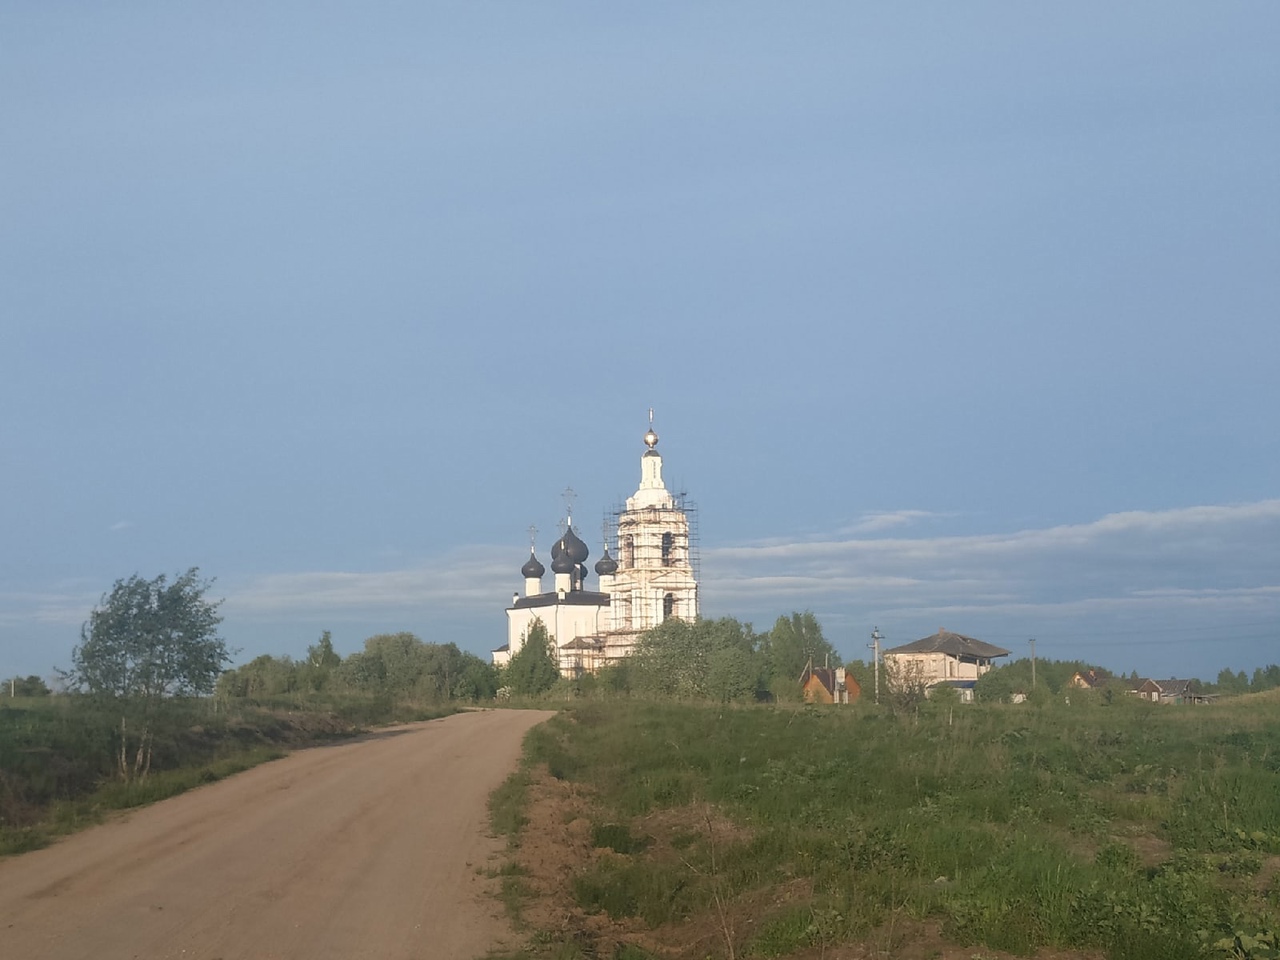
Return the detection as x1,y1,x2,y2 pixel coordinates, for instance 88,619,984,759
0,1,1280,678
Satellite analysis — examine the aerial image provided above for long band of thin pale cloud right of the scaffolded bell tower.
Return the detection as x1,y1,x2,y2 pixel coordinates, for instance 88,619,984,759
703,499,1280,642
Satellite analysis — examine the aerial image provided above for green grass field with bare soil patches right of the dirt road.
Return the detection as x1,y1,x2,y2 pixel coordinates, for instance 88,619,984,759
494,698,1280,960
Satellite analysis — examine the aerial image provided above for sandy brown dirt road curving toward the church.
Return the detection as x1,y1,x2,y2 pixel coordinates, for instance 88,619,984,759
0,710,550,960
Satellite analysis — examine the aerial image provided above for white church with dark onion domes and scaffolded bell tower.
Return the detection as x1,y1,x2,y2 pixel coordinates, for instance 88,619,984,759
493,412,698,677
